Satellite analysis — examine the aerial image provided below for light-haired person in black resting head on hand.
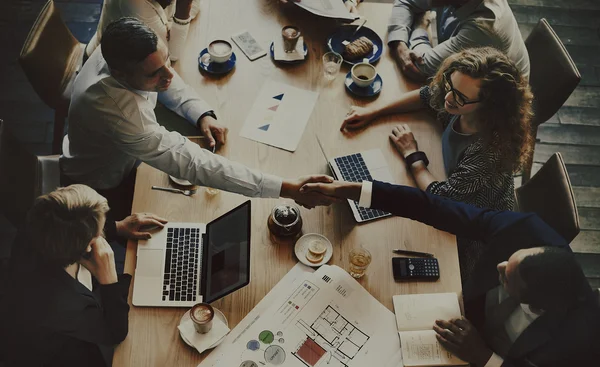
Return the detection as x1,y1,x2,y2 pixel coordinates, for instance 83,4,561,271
0,185,166,366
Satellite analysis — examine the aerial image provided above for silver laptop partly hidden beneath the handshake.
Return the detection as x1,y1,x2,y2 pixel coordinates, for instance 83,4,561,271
317,137,393,223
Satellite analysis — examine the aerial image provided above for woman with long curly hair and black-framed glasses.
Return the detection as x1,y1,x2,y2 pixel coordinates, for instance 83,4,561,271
342,47,533,281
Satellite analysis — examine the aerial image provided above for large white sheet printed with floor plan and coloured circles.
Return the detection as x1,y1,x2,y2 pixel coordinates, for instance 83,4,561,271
200,265,402,367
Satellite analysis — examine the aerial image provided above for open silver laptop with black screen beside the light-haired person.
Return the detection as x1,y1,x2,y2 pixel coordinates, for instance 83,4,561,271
132,200,250,307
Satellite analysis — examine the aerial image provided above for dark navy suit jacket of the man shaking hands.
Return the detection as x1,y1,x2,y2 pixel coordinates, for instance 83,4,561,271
371,181,600,367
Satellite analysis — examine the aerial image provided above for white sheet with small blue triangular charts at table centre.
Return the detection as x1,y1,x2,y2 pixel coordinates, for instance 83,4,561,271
240,80,319,152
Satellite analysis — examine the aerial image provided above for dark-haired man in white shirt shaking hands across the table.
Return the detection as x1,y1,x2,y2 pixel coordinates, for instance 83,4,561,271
60,18,338,219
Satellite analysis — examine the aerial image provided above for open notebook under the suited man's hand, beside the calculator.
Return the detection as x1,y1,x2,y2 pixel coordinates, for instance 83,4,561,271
393,293,467,367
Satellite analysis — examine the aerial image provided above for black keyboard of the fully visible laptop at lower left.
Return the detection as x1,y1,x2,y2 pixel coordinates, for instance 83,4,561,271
162,228,202,301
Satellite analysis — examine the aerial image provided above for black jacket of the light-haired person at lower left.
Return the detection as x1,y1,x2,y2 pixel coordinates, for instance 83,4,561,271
0,230,131,366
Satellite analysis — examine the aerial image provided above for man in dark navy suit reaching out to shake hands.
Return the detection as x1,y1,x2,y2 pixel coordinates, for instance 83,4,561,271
301,181,600,367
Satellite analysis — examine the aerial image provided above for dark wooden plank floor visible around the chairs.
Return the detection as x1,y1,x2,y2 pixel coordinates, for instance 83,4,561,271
0,0,600,286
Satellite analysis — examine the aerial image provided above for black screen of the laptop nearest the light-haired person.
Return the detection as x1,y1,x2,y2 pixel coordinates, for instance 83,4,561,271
201,200,250,303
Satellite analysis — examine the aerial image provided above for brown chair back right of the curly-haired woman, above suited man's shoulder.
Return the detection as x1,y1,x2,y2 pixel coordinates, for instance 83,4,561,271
516,153,579,242
